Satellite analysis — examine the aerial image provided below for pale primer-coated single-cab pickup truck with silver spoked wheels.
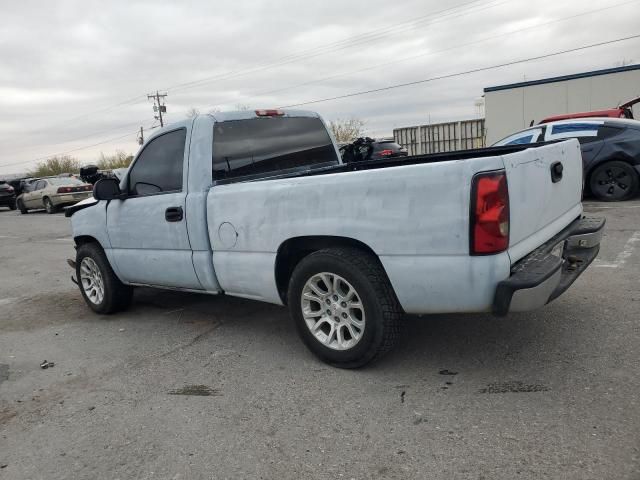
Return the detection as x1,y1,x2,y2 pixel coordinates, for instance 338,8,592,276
66,110,604,367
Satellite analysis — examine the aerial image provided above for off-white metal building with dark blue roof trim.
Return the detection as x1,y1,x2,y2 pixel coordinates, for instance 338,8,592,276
484,64,640,145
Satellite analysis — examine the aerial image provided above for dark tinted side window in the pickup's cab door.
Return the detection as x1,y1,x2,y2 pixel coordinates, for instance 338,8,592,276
128,128,187,196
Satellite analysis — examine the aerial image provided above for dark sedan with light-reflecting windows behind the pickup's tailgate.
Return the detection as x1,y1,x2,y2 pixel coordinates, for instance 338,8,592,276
493,118,640,202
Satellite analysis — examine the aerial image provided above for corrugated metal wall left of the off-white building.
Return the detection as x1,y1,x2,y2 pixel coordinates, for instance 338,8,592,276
393,119,485,155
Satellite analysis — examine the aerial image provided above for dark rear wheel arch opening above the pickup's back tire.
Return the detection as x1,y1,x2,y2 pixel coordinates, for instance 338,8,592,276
275,235,386,305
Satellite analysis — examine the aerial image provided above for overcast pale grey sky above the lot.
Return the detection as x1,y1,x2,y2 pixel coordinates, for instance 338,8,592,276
0,0,640,175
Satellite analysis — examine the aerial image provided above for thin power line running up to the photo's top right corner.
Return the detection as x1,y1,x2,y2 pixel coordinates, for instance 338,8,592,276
224,0,639,104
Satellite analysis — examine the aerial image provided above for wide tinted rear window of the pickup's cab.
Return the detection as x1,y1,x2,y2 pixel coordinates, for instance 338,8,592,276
213,117,339,180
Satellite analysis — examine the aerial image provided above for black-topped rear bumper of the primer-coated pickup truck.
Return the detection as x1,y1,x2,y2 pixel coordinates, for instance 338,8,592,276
493,217,605,316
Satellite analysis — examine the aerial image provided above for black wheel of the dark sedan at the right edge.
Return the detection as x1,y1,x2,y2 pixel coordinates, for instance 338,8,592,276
589,160,640,202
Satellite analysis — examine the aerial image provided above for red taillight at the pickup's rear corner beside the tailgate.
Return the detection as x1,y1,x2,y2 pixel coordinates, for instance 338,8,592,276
470,171,509,255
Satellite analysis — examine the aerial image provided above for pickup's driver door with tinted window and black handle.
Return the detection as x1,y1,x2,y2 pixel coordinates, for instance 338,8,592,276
107,128,202,290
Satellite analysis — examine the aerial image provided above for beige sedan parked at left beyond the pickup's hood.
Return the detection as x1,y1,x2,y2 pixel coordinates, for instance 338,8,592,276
17,177,93,213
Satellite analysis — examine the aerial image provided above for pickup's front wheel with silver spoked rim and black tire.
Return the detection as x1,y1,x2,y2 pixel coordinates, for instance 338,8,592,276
76,243,133,314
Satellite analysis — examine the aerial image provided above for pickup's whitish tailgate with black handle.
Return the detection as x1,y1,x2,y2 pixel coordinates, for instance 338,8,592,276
503,139,582,263
